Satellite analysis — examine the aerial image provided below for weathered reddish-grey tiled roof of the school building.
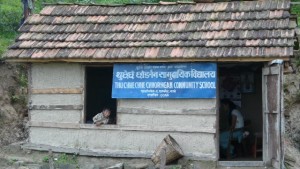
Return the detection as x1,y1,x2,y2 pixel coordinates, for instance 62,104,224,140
5,0,296,61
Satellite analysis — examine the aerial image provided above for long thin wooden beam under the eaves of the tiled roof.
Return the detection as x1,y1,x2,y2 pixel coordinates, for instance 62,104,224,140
6,57,290,63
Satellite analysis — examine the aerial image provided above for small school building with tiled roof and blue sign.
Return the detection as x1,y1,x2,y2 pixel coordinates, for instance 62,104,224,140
5,0,296,168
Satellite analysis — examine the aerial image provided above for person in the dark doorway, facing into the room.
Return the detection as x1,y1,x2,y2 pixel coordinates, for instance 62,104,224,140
220,99,244,158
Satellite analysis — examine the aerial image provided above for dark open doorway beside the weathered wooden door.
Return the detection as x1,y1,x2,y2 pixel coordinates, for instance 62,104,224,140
218,63,263,161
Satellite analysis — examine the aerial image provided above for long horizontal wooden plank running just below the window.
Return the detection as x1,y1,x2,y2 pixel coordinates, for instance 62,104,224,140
29,121,216,134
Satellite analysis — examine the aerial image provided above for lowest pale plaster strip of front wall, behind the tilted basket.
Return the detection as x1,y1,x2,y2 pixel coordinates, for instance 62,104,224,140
30,127,216,160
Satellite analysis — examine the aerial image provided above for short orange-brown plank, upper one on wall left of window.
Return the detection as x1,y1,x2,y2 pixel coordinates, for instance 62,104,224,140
31,88,83,94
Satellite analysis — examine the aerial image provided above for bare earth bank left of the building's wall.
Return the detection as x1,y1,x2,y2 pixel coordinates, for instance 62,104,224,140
0,62,28,146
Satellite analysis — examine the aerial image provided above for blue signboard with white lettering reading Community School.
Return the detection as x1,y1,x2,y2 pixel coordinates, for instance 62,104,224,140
112,63,217,98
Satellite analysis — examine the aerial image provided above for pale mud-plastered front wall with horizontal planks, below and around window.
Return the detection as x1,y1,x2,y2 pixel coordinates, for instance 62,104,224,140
30,63,217,160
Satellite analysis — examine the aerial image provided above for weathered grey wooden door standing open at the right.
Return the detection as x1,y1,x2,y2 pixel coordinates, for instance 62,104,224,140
262,64,284,168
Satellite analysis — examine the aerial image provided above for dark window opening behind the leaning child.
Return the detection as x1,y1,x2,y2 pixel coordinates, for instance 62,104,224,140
85,67,117,124
